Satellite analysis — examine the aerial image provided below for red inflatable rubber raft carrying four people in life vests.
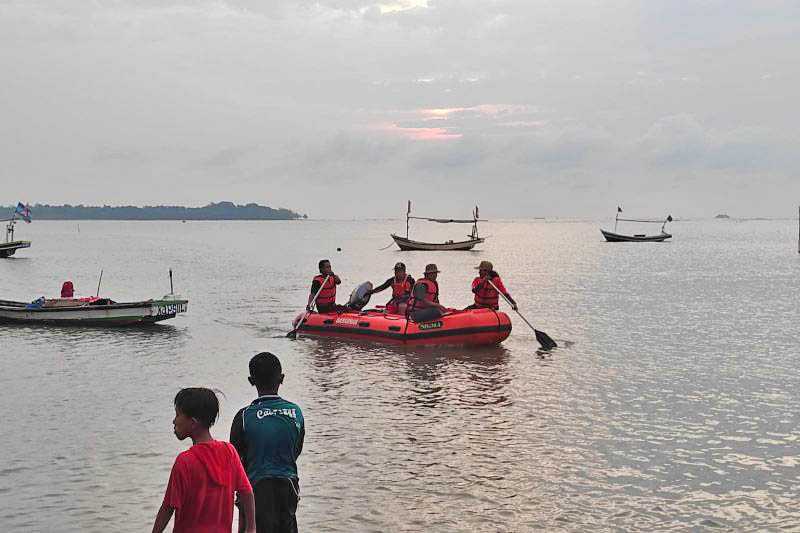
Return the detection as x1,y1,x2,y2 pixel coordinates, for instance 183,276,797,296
293,309,511,346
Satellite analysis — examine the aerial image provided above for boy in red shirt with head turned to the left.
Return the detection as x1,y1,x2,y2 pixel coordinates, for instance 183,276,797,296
153,387,255,533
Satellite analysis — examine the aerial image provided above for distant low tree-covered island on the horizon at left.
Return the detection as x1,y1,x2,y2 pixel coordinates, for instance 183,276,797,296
0,202,308,220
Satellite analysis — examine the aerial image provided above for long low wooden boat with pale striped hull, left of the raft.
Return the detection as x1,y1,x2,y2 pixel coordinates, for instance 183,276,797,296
0,295,189,326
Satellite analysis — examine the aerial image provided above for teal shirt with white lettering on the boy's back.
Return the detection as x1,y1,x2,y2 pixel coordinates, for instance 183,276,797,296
231,396,305,485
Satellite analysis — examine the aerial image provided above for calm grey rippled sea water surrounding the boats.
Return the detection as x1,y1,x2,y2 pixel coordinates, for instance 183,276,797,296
0,220,800,532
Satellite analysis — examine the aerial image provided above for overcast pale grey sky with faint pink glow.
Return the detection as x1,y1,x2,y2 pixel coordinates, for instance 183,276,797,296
0,0,800,218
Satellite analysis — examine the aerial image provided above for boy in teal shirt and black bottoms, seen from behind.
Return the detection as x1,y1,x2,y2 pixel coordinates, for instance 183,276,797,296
231,352,306,533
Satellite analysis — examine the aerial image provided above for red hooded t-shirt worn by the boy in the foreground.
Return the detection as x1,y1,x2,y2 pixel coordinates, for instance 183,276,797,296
164,440,253,533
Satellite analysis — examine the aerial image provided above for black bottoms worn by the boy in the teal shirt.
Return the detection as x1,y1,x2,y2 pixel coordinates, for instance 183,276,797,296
253,478,300,533
